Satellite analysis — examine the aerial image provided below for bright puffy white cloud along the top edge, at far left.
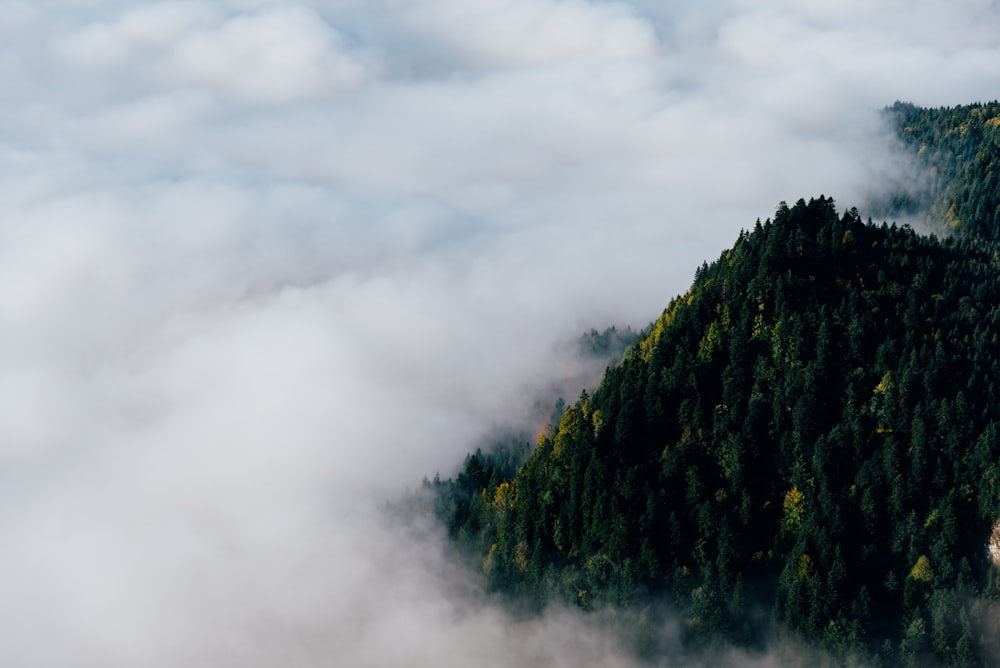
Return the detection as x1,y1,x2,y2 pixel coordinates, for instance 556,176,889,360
52,2,366,104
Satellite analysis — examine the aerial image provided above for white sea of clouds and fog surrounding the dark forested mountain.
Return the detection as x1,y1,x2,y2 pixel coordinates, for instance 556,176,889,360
0,0,1000,668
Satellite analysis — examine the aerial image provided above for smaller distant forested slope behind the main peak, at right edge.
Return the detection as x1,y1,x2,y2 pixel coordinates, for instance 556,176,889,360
887,102,1000,243
